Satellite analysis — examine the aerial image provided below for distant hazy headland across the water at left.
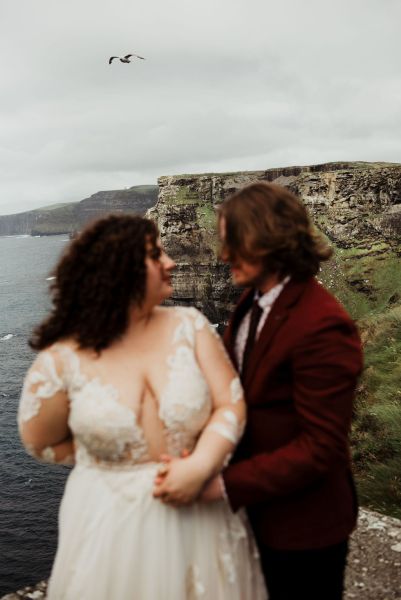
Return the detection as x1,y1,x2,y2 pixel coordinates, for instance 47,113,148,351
0,185,158,235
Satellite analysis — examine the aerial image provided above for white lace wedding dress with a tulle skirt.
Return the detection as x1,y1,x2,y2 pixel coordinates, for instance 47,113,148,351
19,308,267,600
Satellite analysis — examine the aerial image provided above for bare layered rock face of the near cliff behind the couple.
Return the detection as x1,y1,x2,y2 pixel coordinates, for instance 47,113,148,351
149,163,401,320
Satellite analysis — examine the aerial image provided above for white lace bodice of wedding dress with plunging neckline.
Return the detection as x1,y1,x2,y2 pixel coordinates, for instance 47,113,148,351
48,309,213,461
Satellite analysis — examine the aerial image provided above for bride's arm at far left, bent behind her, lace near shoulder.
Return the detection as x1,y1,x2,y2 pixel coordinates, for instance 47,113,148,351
18,350,74,464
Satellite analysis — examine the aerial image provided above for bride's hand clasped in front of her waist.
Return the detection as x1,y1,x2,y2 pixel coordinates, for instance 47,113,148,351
153,456,207,506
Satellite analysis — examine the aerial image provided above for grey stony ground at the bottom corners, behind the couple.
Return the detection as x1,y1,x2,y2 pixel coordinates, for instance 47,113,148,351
0,509,401,600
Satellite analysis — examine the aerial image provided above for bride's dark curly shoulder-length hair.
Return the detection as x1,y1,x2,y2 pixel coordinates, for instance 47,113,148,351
29,214,160,352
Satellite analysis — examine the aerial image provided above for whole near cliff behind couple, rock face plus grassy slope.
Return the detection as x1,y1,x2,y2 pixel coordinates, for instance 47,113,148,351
148,162,401,518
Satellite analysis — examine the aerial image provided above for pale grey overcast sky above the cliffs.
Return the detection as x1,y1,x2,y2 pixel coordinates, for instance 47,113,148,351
0,0,401,214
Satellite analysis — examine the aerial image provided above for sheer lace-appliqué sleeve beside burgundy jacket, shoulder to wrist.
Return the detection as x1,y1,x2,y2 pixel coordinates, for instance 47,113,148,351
186,310,246,472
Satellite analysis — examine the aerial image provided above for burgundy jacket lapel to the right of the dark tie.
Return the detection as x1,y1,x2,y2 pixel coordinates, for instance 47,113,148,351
241,279,310,389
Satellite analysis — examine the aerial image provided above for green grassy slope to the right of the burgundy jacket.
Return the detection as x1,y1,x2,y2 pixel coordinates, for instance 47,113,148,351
319,245,401,518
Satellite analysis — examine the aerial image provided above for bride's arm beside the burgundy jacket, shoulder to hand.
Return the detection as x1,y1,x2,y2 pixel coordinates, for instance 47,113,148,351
154,313,246,504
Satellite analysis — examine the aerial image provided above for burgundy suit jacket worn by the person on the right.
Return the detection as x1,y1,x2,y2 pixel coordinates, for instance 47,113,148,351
223,277,362,550
